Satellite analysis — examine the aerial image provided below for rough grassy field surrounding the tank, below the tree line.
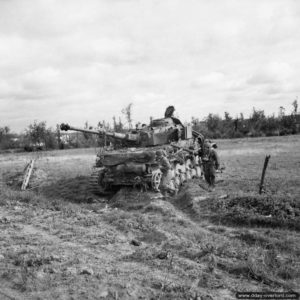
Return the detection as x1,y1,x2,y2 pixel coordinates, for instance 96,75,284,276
0,136,300,300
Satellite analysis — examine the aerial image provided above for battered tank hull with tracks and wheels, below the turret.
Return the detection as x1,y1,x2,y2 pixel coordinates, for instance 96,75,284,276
92,141,202,192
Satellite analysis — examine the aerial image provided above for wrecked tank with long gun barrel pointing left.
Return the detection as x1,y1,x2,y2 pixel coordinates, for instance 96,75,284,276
60,106,204,194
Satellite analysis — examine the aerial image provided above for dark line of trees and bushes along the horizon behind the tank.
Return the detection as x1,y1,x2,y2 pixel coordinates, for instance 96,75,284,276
0,100,300,151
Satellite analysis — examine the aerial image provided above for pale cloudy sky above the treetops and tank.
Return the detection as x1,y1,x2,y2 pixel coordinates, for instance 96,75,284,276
0,0,300,132
